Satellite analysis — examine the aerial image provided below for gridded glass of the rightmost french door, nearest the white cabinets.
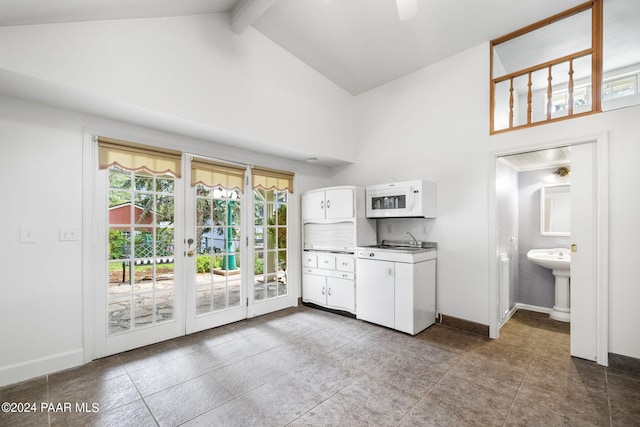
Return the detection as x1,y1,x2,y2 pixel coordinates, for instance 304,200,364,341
253,188,288,301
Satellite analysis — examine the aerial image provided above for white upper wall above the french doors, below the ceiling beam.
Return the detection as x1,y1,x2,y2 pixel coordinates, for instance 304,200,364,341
0,14,355,161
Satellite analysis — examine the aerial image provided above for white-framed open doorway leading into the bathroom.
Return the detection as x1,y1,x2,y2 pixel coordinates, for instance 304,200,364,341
490,135,608,365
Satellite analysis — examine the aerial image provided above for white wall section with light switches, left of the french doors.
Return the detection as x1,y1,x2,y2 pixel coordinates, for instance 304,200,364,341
0,98,83,385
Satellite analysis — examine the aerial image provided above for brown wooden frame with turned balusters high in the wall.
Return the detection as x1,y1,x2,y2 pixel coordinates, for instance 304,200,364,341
489,0,603,135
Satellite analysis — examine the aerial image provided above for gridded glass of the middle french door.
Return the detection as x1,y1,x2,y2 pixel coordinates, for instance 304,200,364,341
195,184,242,315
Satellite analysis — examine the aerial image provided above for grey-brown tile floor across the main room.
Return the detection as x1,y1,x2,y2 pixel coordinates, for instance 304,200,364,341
0,307,640,427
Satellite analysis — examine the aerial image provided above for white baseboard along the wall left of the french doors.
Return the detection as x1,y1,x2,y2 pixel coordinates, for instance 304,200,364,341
0,348,84,387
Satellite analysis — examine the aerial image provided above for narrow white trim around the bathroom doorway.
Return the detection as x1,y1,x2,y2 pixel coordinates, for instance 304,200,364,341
488,131,609,366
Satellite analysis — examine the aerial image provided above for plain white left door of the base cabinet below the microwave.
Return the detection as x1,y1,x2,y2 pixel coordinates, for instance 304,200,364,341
356,258,395,328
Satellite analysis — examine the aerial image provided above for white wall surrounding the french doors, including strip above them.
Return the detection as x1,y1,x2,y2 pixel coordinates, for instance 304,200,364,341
0,96,329,386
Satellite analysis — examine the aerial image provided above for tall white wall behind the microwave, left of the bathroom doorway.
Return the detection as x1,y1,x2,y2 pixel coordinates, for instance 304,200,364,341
332,44,495,325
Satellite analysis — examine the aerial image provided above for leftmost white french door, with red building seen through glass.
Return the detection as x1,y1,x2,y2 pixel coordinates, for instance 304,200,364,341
95,166,184,357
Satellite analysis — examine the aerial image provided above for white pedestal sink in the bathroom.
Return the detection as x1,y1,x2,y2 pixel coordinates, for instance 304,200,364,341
527,248,571,322
